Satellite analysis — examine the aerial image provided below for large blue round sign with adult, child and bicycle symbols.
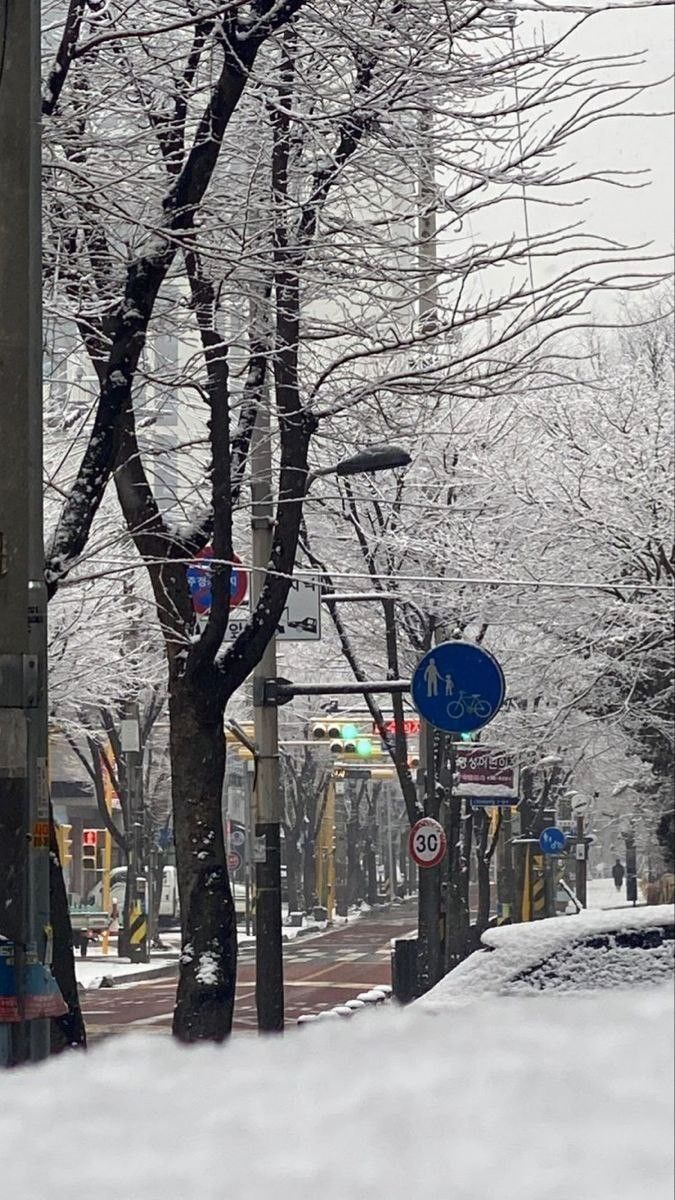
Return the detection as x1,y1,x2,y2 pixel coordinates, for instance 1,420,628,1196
411,642,506,733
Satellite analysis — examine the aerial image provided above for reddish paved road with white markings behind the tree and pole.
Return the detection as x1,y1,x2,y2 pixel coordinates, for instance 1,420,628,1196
82,902,417,1040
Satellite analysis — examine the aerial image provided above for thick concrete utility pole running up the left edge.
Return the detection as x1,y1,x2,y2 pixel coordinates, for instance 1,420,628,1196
0,0,50,1064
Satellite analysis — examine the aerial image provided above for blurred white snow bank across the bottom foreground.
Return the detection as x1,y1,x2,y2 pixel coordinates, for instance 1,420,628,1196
0,988,673,1200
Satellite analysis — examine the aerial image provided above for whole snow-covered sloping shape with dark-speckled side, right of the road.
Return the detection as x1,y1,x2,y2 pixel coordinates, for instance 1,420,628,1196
417,905,675,1010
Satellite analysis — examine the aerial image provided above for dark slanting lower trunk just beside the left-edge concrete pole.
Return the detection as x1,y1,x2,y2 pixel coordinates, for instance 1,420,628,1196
49,805,86,1054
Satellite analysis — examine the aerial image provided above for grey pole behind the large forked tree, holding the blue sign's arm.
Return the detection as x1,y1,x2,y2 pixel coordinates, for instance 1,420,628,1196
251,400,283,1033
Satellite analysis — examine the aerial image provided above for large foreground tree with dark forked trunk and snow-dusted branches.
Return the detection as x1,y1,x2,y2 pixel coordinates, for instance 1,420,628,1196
43,0,667,1040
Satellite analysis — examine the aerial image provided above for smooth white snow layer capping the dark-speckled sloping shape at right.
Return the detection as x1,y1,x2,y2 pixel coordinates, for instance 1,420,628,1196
417,905,675,1012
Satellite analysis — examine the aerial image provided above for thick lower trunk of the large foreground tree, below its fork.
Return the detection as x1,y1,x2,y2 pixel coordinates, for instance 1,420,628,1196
169,668,237,1042
